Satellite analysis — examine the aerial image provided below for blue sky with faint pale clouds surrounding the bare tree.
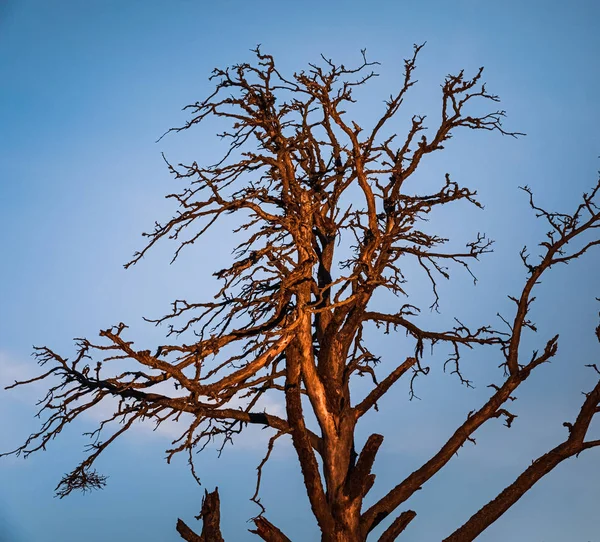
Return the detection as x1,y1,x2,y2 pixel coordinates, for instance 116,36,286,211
0,0,600,542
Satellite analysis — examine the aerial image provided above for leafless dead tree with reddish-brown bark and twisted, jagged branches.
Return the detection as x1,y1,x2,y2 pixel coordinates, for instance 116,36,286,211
2,46,600,542
